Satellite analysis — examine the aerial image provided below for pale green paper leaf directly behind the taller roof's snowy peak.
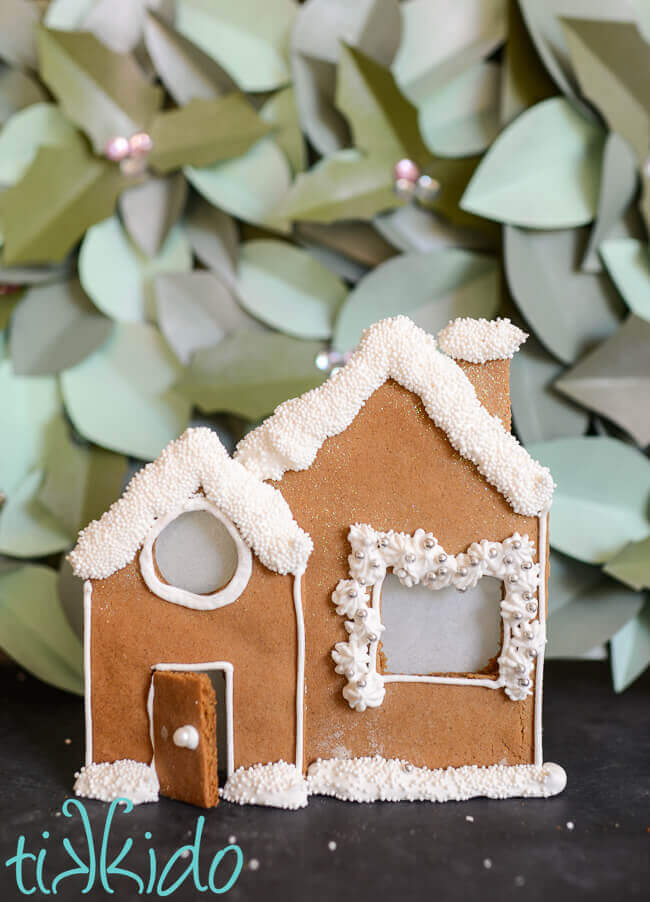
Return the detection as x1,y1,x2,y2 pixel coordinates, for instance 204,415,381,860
334,248,500,351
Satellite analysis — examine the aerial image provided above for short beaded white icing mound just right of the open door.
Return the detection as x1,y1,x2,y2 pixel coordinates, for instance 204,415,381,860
220,761,307,808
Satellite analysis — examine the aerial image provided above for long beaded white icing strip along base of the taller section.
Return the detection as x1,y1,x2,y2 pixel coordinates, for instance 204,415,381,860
307,755,566,802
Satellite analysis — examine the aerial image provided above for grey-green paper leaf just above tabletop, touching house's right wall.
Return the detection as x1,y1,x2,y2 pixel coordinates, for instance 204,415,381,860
546,579,643,658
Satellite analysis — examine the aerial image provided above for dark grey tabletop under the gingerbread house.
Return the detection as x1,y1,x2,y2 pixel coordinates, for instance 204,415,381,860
0,662,650,902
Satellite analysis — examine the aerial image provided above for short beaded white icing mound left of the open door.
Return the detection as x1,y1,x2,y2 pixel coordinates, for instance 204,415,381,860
74,758,160,805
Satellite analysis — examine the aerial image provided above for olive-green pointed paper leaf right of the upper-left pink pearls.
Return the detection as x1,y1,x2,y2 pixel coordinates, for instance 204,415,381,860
150,94,269,172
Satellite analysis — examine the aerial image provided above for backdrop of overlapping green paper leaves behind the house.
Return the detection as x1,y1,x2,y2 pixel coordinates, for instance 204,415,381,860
0,0,650,691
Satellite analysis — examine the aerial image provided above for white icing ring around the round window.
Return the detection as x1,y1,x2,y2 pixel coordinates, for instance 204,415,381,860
140,495,253,611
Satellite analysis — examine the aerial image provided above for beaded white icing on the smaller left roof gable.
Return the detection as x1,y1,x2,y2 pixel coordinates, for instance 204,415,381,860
69,428,313,579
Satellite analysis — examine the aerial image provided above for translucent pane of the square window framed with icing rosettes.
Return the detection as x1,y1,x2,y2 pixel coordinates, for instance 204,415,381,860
381,573,503,674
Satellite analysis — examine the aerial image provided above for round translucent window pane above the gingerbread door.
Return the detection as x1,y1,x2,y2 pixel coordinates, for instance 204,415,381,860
154,511,237,595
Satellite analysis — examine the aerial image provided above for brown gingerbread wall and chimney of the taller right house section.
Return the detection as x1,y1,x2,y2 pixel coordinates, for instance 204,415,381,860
274,361,538,767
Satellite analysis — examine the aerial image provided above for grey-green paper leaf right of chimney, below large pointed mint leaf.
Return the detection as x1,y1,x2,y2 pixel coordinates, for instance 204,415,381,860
504,226,625,363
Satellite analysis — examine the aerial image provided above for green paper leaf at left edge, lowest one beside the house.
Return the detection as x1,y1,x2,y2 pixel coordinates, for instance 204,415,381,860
0,564,84,695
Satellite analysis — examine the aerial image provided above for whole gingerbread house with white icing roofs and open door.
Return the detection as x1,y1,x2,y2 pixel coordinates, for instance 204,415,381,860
70,317,565,808
